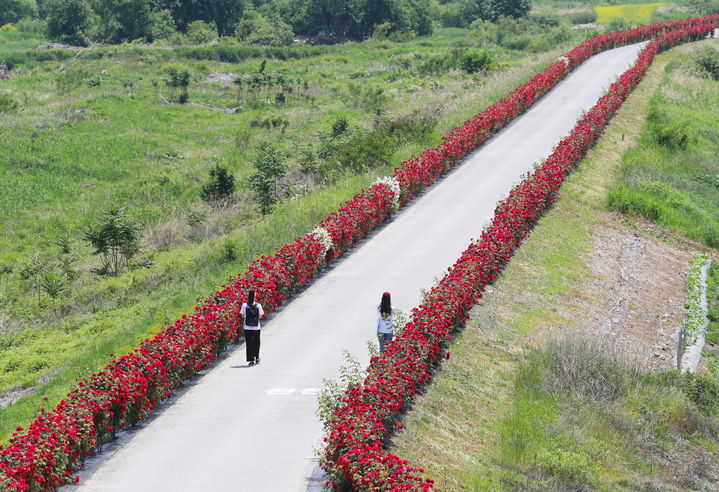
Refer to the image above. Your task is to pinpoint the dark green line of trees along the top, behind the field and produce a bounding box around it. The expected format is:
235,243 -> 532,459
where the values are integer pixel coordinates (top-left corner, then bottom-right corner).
0,0 -> 531,46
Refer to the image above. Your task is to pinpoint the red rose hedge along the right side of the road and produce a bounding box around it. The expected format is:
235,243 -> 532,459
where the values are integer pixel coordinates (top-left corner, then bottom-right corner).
322,16 -> 719,491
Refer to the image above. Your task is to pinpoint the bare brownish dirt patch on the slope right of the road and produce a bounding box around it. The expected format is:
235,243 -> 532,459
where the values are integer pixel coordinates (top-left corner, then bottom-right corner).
531,213 -> 698,370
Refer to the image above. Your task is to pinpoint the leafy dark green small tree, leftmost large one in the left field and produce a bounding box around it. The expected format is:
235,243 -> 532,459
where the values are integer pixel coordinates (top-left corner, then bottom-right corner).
84,207 -> 142,275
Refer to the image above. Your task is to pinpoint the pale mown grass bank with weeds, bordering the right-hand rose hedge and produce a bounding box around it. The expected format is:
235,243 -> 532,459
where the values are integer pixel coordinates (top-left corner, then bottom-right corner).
391,41 -> 719,491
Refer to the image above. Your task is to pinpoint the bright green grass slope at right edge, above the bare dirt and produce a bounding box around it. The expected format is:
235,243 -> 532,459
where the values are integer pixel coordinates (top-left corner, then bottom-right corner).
609,47 -> 719,248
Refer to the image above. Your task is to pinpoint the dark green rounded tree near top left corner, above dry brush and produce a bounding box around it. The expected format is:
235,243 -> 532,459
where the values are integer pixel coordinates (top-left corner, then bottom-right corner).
45,0 -> 93,46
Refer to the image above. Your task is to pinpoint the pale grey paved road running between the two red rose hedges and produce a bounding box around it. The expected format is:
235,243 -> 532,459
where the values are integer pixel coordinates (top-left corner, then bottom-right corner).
66,45 -> 640,492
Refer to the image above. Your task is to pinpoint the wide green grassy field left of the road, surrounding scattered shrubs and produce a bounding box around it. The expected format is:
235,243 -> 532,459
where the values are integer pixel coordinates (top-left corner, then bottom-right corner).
0,24 -> 575,436
